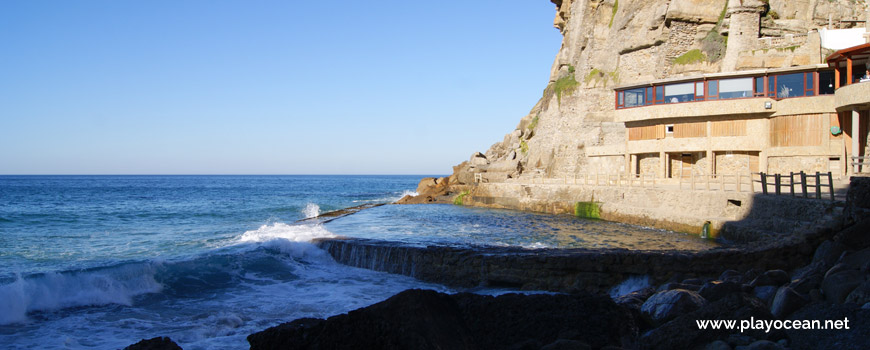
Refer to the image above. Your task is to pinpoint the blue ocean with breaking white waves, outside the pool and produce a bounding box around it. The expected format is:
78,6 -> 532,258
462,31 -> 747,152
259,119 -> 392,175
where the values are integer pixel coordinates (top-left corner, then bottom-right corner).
0,176 -> 451,350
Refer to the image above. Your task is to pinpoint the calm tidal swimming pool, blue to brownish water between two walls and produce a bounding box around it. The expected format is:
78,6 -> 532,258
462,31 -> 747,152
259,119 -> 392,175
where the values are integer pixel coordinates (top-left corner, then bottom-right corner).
324,204 -> 719,251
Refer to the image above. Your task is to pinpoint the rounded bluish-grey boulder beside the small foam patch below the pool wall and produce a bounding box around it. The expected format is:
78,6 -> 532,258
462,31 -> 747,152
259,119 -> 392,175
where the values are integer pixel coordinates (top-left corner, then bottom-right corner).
640,289 -> 707,325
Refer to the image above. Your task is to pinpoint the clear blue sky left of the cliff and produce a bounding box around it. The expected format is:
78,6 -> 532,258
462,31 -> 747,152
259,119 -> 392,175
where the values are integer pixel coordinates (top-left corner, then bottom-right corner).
0,0 -> 561,174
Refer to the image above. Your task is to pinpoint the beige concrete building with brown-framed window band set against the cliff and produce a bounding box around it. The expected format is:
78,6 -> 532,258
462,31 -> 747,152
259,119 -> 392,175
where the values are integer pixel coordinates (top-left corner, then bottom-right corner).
612,6 -> 870,182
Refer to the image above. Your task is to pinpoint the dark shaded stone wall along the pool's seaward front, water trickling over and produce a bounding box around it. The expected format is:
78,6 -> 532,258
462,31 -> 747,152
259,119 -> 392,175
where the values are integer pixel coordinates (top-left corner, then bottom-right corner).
316,231 -> 819,293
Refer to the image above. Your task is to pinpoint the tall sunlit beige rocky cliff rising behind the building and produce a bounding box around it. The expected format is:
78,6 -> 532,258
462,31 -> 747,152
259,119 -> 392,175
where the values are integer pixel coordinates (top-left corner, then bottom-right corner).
404,0 -> 866,202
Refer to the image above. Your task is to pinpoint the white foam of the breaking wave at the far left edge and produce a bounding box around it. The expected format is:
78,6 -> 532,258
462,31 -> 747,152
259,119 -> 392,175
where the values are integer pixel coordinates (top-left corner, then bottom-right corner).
0,264 -> 163,324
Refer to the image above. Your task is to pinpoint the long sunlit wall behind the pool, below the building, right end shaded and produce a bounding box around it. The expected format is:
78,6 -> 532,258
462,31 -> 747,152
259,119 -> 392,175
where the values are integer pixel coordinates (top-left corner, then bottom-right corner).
454,183 -> 843,242
